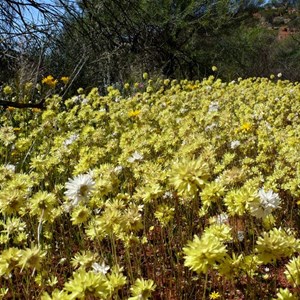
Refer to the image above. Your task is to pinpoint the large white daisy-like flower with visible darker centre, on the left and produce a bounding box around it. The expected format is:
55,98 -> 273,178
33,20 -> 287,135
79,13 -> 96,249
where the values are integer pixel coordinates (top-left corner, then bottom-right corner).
65,174 -> 95,206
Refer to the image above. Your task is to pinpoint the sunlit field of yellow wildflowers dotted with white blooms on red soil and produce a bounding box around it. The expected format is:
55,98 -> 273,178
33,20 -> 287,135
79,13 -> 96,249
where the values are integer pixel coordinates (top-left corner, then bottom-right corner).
0,76 -> 300,300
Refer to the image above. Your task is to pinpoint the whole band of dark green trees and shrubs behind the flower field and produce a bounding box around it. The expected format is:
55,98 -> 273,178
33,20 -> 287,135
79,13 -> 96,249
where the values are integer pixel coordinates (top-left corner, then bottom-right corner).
4,0 -> 299,95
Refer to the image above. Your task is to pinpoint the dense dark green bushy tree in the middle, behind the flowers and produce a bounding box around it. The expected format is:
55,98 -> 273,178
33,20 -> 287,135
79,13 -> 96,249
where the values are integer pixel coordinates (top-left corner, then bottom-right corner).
50,0 -> 257,86
